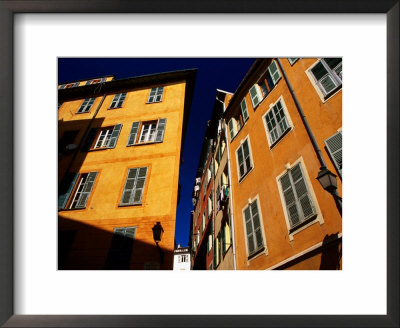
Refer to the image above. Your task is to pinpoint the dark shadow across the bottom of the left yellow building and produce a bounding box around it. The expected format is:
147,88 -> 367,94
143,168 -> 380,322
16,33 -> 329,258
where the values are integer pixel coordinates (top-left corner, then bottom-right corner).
58,215 -> 173,270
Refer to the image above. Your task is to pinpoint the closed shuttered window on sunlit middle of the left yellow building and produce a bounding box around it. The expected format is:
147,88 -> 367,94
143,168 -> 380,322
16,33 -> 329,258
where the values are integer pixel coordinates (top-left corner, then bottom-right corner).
120,167 -> 147,206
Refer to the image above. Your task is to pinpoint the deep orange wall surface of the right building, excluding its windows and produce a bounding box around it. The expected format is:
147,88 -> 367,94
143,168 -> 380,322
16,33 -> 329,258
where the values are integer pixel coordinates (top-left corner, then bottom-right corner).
226,58 -> 342,270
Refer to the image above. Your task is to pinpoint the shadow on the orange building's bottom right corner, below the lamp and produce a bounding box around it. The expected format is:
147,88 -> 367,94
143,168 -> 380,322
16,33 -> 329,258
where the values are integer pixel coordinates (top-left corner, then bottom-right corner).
275,233 -> 342,270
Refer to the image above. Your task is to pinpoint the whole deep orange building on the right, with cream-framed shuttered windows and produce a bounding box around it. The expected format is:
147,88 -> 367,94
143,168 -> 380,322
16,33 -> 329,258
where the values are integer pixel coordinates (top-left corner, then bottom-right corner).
225,58 -> 342,270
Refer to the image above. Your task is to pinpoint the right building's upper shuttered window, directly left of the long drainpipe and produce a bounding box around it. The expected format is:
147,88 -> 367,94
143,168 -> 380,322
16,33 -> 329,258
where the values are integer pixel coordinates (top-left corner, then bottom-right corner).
264,100 -> 290,146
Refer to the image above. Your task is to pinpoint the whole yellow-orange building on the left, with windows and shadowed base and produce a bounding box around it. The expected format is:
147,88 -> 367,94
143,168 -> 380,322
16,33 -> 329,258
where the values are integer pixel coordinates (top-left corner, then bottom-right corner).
58,70 -> 196,270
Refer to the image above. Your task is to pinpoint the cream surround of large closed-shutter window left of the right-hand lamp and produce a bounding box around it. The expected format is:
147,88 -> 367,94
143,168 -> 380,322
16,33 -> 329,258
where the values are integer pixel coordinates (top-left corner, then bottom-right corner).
276,157 -> 324,241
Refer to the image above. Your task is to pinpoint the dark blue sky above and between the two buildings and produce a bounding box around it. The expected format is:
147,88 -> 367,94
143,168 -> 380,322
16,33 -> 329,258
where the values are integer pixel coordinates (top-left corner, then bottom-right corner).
58,58 -> 255,246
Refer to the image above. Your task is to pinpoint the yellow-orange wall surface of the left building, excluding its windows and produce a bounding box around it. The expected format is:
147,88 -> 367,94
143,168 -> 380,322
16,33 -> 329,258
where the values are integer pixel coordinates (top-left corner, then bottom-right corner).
59,82 -> 185,269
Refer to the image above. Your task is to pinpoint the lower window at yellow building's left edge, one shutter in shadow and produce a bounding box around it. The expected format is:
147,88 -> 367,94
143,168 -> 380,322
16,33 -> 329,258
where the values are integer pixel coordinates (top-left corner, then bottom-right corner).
58,172 -> 97,209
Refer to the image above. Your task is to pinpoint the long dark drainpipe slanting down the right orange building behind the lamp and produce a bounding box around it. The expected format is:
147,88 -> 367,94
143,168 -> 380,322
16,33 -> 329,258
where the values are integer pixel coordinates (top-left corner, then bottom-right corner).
276,58 -> 342,215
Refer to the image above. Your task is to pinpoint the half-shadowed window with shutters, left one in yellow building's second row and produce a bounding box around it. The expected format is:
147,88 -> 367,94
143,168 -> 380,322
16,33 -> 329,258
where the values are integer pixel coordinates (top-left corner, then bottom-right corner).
82,124 -> 122,151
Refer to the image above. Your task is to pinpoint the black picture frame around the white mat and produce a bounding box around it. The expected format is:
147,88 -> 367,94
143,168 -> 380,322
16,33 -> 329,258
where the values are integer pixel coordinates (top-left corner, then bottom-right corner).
0,0 -> 399,327
